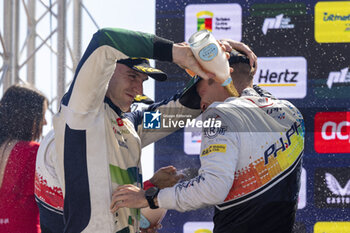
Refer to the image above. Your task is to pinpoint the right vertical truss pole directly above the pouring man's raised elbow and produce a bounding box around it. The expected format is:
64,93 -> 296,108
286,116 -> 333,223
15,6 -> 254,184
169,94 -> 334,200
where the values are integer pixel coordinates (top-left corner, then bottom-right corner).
73,0 -> 82,71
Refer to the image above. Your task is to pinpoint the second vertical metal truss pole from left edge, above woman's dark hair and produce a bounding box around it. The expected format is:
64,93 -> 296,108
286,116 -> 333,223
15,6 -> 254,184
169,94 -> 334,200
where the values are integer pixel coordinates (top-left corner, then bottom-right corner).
11,0 -> 19,85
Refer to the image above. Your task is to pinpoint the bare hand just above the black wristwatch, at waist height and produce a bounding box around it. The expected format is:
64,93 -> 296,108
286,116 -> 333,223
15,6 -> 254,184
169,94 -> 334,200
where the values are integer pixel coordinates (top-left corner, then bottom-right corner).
150,166 -> 184,189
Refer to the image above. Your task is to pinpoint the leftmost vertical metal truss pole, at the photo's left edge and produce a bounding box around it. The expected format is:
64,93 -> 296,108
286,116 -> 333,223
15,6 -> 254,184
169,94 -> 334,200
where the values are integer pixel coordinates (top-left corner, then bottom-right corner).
3,1 -> 13,92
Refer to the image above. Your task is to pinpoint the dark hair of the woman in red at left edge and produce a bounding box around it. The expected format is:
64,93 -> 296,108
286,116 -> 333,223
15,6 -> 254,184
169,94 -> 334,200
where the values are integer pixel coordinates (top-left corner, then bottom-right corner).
0,84 -> 48,145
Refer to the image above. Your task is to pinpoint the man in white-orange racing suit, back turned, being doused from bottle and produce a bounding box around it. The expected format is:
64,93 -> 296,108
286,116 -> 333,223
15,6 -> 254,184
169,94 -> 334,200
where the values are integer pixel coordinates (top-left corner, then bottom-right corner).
111,52 -> 305,233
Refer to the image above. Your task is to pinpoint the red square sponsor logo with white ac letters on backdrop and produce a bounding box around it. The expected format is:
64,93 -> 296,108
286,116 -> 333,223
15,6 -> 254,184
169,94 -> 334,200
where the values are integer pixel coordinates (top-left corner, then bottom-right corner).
314,112 -> 350,153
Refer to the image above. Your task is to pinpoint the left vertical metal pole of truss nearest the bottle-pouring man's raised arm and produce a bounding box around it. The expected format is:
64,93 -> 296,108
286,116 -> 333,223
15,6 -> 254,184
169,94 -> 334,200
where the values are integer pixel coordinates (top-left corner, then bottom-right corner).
57,0 -> 66,108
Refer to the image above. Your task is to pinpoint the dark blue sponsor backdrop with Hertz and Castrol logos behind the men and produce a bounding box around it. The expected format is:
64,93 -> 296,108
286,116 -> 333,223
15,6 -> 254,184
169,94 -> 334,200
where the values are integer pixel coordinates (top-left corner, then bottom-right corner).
154,0 -> 350,233
